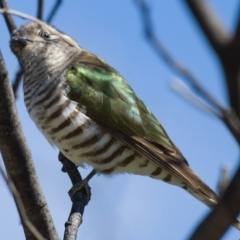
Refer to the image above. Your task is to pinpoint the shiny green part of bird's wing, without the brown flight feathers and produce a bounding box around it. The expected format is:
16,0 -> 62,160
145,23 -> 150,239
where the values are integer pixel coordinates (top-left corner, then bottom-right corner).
67,51 -> 176,156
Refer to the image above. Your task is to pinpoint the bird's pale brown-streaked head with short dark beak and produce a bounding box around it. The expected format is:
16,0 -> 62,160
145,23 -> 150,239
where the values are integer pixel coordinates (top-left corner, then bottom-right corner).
10,22 -> 81,71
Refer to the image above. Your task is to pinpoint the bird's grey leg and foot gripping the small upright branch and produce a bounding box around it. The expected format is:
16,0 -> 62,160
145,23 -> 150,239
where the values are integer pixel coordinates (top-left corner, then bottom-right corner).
68,169 -> 96,205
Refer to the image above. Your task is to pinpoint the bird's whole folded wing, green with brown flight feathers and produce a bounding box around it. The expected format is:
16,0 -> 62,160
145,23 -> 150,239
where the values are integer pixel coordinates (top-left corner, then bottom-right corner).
66,51 -> 218,202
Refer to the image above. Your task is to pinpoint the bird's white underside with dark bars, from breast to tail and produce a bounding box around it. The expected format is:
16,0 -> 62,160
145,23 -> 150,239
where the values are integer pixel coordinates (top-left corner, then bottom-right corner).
25,79 -> 215,210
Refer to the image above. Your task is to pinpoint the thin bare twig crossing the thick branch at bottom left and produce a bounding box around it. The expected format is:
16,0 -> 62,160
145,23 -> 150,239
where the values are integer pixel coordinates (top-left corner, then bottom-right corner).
0,164 -> 45,240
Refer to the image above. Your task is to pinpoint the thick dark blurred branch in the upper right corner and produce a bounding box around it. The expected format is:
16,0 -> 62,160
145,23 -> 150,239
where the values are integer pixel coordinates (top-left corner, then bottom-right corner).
185,0 -> 240,117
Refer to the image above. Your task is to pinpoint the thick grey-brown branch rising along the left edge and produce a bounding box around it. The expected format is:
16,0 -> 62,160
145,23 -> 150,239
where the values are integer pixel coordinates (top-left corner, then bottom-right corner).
0,49 -> 59,240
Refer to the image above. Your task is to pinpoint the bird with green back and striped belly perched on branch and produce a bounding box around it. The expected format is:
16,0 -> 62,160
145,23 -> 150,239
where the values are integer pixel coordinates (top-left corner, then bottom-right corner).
10,21 -> 240,229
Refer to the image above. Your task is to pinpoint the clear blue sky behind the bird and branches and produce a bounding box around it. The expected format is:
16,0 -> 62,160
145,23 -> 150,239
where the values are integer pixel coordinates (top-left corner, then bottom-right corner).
0,0 -> 240,240
